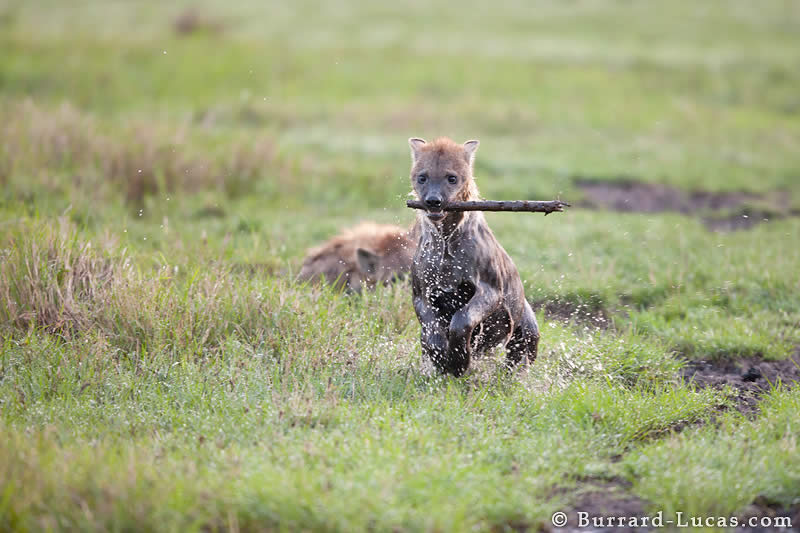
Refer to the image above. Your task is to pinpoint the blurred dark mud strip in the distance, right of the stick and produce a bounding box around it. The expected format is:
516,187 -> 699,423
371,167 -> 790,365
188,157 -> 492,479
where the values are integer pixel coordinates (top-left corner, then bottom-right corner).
575,176 -> 798,231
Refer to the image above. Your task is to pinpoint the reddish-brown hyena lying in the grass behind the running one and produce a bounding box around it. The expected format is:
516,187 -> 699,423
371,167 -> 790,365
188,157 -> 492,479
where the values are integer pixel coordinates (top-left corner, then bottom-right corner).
298,222 -> 417,292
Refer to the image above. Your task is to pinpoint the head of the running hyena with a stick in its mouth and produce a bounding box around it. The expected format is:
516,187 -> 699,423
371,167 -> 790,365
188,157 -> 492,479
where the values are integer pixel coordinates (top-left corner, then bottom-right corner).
408,137 -> 479,223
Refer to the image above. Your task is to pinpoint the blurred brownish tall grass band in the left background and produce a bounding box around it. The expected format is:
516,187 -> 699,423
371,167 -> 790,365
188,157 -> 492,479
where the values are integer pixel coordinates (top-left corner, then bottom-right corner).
0,100 -> 286,204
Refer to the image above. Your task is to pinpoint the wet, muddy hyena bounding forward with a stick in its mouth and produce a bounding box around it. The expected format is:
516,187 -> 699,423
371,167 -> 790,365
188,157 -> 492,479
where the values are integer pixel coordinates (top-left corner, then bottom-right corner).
409,138 -> 539,376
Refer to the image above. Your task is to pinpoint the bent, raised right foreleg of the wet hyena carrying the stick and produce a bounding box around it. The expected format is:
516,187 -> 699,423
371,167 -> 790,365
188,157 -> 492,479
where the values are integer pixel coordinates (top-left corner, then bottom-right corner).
447,284 -> 501,376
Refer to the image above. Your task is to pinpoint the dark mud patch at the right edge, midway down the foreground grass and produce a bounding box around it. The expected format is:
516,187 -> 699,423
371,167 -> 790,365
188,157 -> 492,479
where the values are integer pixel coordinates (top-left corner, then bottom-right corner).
682,352 -> 800,415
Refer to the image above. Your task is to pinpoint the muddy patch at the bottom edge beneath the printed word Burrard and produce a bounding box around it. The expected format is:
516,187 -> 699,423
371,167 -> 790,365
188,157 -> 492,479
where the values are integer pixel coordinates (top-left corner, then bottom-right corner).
545,478 -> 650,533
